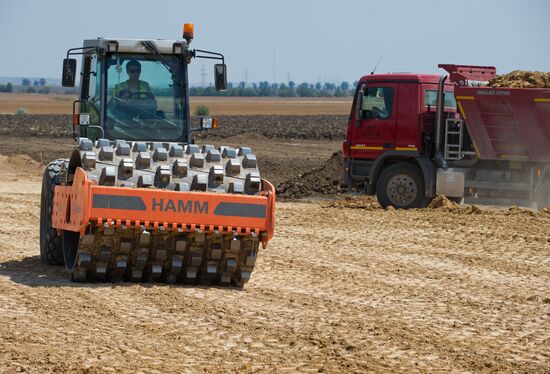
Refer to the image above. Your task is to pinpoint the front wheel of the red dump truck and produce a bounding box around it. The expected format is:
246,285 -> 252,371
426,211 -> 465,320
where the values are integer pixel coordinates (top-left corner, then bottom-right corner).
376,162 -> 429,209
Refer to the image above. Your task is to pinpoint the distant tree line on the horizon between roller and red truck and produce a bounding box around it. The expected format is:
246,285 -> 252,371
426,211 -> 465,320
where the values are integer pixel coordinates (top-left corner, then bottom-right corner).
189,81 -> 356,97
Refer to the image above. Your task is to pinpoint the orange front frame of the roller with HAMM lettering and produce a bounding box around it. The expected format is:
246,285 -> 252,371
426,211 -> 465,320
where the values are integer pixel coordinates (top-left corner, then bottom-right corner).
52,168 -> 275,248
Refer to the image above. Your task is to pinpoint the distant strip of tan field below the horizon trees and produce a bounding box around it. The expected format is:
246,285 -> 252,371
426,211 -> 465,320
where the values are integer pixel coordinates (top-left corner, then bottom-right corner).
0,93 -> 352,115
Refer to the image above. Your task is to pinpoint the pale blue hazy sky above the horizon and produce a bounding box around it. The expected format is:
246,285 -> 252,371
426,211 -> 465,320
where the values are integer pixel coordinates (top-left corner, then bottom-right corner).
0,0 -> 550,83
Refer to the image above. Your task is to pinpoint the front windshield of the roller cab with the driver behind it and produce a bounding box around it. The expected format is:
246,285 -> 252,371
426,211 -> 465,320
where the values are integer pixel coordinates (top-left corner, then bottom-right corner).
105,54 -> 187,141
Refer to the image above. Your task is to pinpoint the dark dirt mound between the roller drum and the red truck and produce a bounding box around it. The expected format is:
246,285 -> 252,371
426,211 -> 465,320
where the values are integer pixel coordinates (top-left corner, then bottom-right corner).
277,151 -> 344,199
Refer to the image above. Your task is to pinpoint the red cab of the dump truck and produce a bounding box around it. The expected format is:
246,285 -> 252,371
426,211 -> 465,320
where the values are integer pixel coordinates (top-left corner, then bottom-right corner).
343,74 -> 456,207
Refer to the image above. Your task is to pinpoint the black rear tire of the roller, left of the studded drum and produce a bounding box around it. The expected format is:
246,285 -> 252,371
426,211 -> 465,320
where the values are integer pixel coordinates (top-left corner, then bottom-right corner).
40,160 -> 67,265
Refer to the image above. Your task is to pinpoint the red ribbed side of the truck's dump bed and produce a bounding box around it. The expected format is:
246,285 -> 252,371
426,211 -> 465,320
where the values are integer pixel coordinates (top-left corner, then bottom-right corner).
454,85 -> 550,162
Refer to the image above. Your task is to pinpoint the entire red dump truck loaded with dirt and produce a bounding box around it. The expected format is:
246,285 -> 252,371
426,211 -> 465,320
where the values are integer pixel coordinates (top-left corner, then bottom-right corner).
343,64 -> 550,209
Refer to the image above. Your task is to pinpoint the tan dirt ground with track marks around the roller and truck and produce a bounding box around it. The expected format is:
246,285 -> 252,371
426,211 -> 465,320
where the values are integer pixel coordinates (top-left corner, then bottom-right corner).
0,115 -> 550,373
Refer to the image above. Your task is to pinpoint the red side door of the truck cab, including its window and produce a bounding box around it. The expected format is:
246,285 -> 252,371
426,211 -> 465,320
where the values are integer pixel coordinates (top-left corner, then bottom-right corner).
349,82 -> 397,160
